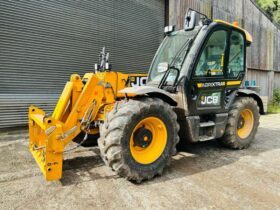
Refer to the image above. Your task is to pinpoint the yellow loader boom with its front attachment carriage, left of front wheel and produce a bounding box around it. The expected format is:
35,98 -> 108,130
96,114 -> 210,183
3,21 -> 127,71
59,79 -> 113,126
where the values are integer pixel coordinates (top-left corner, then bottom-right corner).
29,72 -> 146,180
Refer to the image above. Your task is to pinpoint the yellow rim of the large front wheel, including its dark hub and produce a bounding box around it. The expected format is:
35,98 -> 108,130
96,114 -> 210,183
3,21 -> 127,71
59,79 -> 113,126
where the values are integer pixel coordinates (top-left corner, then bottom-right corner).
130,117 -> 167,164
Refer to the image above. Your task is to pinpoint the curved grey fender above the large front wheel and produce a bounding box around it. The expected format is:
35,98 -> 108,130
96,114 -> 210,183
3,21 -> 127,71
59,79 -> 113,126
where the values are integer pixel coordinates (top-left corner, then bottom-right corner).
119,85 -> 177,106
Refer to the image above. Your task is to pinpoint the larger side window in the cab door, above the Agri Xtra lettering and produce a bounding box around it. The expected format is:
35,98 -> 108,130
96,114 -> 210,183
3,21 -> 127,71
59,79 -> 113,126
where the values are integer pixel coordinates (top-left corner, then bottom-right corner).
194,30 -> 227,77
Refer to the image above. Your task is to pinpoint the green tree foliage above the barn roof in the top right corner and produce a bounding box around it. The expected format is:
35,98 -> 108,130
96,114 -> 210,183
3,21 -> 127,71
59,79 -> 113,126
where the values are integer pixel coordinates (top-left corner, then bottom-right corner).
256,0 -> 280,23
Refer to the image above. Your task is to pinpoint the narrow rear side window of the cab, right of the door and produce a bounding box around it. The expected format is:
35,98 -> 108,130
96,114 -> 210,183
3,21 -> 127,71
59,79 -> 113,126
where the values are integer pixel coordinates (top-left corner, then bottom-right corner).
228,31 -> 245,78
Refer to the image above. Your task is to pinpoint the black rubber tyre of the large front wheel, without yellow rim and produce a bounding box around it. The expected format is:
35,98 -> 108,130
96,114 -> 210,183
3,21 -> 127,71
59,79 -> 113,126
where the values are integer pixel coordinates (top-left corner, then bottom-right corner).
98,97 -> 179,183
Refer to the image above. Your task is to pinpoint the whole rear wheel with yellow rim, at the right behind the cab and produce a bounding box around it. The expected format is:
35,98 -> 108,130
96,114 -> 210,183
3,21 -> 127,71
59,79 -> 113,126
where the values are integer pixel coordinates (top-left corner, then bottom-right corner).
218,97 -> 260,149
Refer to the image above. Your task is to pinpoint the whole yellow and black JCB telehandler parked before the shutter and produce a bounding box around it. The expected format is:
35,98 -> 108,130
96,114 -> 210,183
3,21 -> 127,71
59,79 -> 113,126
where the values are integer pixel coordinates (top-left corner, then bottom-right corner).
29,9 -> 263,182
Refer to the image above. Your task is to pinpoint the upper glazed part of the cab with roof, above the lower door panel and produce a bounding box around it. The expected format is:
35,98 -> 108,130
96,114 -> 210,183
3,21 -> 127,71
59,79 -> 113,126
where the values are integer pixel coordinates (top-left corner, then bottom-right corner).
148,9 -> 252,89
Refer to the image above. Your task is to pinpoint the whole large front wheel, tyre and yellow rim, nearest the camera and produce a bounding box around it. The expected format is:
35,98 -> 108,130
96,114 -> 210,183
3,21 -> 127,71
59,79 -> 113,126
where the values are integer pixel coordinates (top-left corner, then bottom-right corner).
98,98 -> 179,183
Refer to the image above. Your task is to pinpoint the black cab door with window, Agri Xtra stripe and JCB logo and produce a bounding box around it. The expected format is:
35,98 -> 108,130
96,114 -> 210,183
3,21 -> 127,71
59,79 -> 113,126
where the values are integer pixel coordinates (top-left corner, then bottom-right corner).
186,27 -> 229,115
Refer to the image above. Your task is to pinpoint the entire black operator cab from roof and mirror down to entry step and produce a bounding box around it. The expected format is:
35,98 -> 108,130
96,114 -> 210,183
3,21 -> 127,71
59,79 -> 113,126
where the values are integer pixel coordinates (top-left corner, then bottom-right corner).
148,9 -> 252,141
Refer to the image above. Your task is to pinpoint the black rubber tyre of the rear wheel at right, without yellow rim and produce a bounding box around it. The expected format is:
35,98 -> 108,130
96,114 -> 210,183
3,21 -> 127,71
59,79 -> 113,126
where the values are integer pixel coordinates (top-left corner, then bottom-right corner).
218,97 -> 260,149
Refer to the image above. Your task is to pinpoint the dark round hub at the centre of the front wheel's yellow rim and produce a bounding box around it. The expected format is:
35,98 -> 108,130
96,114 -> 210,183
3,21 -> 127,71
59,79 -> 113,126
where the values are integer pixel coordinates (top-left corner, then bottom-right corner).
133,126 -> 153,148
